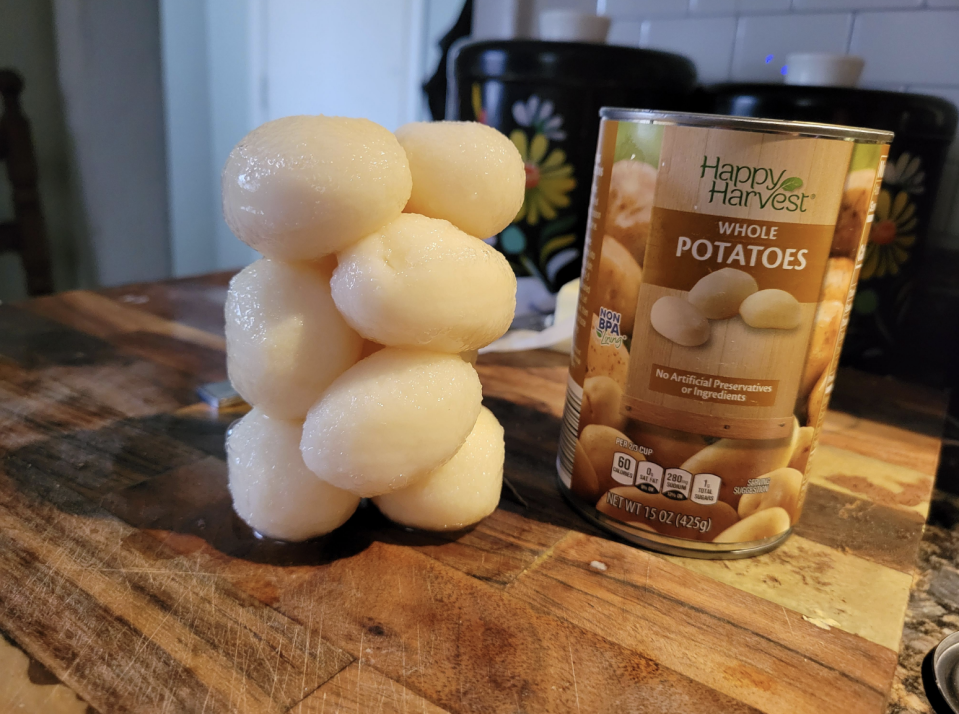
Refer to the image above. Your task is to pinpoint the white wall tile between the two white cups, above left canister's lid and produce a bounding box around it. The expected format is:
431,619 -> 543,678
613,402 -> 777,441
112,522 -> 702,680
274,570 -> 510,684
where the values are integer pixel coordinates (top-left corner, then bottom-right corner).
639,17 -> 736,82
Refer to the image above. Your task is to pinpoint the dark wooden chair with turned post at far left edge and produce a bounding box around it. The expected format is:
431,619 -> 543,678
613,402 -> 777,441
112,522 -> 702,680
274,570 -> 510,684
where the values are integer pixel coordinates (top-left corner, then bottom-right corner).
0,69 -> 53,296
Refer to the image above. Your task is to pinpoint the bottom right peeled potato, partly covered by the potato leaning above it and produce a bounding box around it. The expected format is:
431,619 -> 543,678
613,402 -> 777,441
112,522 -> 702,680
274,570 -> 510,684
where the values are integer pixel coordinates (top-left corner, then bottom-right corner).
373,407 -> 506,531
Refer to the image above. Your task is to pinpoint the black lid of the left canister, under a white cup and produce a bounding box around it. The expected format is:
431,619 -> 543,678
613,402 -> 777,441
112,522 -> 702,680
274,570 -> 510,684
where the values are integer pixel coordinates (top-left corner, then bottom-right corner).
454,40 -> 696,93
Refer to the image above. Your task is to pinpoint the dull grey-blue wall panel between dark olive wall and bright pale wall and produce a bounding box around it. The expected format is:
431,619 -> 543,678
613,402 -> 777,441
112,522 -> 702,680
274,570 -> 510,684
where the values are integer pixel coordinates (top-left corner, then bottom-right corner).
54,0 -> 170,285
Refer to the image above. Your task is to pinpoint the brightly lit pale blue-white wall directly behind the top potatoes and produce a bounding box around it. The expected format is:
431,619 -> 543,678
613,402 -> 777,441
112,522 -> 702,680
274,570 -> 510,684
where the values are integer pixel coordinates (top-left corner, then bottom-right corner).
160,0 -> 454,275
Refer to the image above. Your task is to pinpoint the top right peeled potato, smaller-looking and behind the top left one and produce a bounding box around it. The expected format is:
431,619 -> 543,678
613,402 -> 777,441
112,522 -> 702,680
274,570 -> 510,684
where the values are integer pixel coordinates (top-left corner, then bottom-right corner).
396,121 -> 526,238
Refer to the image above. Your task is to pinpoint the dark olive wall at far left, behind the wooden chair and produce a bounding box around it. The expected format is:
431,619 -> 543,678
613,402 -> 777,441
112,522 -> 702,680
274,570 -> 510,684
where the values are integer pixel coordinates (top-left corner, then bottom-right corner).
0,0 -> 94,301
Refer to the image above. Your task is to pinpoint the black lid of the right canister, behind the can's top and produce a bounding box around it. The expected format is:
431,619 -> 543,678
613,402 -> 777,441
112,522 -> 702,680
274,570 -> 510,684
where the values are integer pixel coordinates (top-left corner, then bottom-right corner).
703,84 -> 959,141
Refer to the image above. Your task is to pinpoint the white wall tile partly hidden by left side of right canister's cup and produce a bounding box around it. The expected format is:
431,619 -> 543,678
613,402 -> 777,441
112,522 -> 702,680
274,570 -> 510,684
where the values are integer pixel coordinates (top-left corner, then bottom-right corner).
732,13 -> 853,82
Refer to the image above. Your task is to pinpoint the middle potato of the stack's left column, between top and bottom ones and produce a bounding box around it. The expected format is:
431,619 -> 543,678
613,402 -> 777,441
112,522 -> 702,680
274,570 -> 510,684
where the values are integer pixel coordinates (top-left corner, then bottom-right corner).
225,256 -> 363,419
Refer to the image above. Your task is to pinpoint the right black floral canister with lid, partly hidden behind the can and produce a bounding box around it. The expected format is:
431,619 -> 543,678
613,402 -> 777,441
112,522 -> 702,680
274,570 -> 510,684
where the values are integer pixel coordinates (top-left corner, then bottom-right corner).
699,84 -> 957,386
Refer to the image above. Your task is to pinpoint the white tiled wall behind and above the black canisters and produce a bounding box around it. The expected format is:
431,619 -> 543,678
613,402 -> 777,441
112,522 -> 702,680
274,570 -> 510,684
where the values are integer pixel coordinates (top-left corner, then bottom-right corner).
537,0 -> 959,250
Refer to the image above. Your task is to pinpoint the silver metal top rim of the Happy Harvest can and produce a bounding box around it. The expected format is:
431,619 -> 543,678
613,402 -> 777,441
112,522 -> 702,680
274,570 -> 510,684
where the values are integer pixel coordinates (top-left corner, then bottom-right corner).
599,107 -> 894,144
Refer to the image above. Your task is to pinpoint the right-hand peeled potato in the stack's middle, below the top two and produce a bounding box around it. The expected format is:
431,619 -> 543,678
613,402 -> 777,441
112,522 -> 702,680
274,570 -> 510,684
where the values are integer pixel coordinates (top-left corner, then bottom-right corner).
331,214 -> 516,352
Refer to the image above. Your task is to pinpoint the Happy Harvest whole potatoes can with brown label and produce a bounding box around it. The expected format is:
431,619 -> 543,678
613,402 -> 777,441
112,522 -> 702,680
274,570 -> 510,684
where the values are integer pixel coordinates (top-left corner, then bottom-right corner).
557,108 -> 892,558
